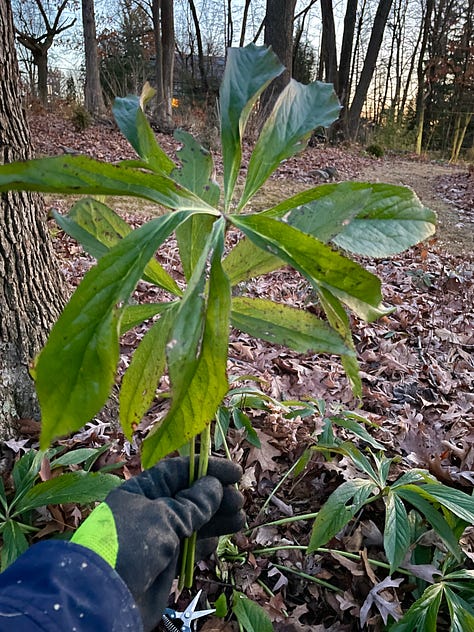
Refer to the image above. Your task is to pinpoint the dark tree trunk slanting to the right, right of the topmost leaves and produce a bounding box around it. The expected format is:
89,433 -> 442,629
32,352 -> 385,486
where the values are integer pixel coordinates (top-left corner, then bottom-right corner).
348,0 -> 393,138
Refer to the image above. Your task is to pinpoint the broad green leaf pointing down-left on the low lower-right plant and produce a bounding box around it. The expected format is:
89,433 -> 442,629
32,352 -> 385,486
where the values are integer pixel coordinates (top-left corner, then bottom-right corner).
308,478 -> 377,553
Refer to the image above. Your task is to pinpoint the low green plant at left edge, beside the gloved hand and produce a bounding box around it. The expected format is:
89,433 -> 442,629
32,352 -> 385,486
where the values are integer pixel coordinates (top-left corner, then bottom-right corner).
0,448 -> 122,571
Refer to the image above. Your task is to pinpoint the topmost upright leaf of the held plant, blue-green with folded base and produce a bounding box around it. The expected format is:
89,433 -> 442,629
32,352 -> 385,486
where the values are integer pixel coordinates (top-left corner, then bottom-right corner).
219,44 -> 284,209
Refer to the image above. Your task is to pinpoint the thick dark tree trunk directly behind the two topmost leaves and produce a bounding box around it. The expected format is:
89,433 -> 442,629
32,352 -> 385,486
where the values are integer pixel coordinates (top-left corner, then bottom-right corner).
260,0 -> 296,118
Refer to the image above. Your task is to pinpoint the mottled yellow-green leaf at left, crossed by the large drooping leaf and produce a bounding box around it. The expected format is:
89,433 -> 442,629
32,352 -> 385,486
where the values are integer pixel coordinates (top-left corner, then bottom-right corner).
64,198 -> 182,296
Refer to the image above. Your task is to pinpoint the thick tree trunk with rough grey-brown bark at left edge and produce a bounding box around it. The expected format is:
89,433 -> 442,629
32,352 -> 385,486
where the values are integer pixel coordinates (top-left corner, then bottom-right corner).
0,0 -> 64,440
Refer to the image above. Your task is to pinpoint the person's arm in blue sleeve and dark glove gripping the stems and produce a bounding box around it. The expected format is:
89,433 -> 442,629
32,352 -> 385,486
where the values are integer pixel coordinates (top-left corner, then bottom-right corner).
0,458 -> 244,632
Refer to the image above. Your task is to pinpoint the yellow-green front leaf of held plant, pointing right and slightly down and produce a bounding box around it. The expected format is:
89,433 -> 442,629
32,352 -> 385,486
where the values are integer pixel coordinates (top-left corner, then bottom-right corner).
229,215 -> 382,318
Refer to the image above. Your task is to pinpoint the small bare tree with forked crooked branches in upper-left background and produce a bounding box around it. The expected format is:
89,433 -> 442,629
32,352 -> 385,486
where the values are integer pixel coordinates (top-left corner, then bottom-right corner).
15,0 -> 76,105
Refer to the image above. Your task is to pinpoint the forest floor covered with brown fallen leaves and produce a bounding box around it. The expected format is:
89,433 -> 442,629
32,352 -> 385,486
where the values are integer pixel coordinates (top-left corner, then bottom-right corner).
24,115 -> 474,632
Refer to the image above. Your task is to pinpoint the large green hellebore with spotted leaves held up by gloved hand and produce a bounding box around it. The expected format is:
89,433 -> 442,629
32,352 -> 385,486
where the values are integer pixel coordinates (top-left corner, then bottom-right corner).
0,44 -> 435,588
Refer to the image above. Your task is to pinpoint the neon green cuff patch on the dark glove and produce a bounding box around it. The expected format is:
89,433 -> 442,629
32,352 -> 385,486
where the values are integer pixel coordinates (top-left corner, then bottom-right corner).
71,503 -> 118,568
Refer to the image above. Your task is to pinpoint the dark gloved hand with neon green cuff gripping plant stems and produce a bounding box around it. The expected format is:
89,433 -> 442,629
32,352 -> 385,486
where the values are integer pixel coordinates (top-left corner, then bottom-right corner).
72,457 -> 245,631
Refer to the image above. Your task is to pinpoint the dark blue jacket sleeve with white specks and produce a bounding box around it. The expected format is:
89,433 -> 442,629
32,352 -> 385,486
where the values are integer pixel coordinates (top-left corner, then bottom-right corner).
0,540 -> 143,632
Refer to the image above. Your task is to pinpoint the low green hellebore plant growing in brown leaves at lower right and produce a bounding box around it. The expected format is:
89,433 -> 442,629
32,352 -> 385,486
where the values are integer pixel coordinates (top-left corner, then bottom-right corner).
308,441 -> 474,632
